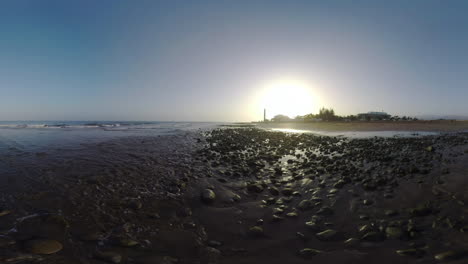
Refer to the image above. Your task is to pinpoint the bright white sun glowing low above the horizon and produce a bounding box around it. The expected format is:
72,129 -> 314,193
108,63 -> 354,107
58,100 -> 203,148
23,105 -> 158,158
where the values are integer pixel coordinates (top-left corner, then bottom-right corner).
261,80 -> 317,118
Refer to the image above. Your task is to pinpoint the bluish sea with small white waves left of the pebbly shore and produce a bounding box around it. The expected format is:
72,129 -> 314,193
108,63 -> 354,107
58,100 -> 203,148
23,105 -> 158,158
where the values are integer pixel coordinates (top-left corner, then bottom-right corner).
0,121 -> 219,152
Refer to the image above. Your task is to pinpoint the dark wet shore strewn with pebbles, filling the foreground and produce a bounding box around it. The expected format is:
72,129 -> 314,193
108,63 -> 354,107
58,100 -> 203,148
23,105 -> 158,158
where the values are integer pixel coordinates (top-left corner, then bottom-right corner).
0,127 -> 468,264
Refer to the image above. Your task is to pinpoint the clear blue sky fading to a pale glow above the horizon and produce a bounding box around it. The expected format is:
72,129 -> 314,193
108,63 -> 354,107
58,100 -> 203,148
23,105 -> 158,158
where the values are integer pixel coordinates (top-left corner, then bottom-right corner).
0,0 -> 468,121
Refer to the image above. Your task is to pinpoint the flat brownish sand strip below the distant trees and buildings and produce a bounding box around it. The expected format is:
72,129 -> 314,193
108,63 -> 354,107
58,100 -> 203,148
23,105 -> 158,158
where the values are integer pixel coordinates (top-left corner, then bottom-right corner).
255,120 -> 468,132
